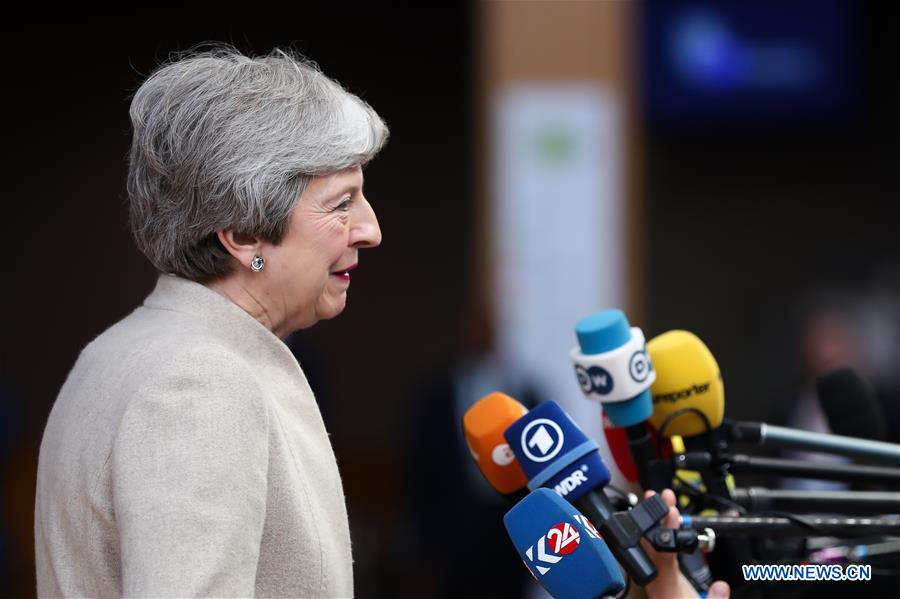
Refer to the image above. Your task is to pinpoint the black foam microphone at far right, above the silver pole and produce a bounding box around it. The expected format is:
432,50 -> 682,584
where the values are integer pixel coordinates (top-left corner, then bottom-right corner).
816,367 -> 887,441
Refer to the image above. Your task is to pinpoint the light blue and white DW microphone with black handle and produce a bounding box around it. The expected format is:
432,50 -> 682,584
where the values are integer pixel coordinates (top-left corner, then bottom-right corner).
569,310 -> 674,492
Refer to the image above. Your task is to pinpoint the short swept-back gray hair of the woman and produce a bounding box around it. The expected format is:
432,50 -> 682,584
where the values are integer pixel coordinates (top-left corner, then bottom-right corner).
127,47 -> 388,281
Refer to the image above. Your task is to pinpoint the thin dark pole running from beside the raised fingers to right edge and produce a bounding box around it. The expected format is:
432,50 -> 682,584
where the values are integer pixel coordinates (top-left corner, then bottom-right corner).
681,516 -> 900,537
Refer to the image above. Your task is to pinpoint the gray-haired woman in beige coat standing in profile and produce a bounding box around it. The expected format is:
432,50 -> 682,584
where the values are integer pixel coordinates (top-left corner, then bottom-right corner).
35,48 -> 388,597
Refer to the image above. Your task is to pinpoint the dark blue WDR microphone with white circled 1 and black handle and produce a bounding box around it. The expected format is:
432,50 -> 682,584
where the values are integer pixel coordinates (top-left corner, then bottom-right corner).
503,401 -> 657,585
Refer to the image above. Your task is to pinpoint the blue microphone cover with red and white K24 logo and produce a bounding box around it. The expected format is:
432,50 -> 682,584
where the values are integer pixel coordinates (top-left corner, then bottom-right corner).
503,489 -> 625,599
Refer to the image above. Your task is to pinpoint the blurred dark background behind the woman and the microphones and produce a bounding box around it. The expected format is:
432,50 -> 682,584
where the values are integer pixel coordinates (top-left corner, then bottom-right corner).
0,0 -> 900,597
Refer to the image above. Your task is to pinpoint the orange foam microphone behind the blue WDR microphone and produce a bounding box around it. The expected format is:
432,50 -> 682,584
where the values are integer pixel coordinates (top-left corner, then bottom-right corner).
463,392 -> 528,495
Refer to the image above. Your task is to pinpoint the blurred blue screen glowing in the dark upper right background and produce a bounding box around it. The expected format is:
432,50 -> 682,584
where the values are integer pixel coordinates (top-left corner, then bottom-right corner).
639,0 -> 860,128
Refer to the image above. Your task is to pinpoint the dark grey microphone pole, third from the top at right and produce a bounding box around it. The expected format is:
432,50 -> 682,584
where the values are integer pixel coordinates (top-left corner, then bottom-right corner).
732,487 -> 900,515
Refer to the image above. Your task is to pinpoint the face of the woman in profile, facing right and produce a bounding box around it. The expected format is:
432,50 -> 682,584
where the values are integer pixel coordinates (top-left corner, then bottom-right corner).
262,167 -> 381,331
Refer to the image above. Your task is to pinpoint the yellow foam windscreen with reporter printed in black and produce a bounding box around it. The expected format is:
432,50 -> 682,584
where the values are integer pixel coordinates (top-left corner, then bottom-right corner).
647,330 -> 725,437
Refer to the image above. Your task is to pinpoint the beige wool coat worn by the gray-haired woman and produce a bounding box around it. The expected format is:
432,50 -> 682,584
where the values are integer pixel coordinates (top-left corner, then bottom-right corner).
35,275 -> 353,597
